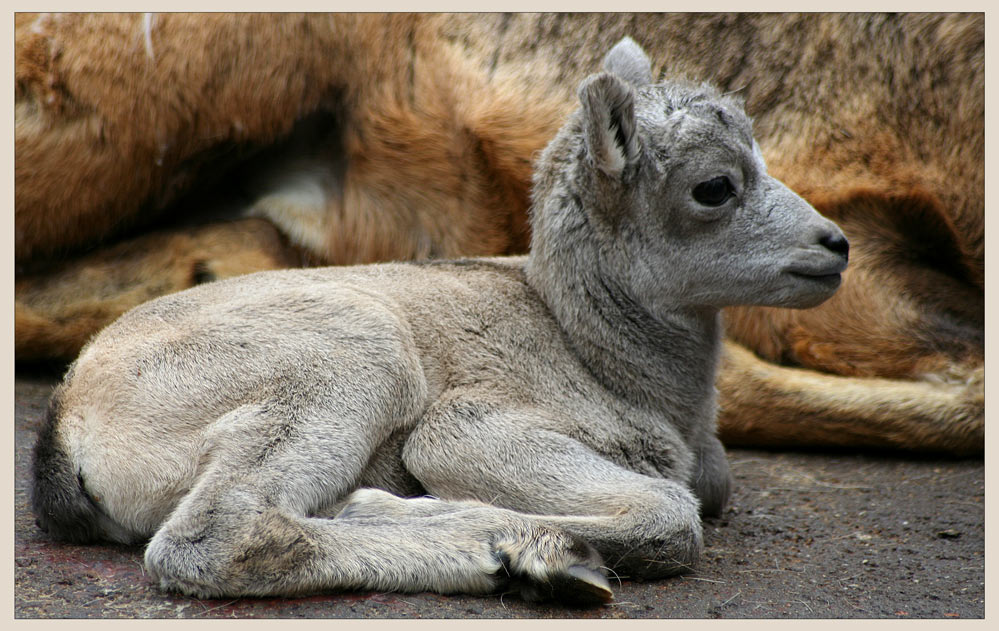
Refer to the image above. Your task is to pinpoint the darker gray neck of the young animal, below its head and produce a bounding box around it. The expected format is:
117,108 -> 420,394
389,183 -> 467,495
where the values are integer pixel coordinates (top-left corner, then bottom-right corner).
527,241 -> 721,433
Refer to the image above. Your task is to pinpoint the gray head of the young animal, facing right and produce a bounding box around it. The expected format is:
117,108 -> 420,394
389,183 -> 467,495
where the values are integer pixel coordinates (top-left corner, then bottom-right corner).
531,39 -> 847,313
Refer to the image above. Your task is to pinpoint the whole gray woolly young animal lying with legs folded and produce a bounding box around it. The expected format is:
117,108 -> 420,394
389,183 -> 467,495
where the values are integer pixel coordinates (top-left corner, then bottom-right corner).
34,43 -> 846,602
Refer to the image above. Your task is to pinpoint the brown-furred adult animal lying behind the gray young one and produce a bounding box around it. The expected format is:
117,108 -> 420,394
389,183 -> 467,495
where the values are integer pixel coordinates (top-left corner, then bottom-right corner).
15,14 -> 985,453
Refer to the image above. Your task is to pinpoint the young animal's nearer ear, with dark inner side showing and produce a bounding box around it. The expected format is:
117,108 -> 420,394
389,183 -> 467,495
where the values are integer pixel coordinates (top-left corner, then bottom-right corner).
579,73 -> 639,178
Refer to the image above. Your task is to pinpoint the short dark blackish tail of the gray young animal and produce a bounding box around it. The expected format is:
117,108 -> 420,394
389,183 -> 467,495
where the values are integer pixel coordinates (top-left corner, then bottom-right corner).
31,389 -> 120,543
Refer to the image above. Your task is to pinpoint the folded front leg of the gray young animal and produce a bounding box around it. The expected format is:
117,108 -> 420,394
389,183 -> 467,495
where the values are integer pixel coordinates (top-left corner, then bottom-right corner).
403,402 -> 702,578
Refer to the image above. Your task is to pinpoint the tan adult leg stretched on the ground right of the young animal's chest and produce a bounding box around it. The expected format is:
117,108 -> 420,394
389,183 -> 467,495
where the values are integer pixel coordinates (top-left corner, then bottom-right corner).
718,342 -> 985,456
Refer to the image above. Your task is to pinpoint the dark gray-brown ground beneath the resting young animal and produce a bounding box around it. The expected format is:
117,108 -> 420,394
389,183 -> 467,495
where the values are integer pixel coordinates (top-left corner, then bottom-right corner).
14,370 -> 985,619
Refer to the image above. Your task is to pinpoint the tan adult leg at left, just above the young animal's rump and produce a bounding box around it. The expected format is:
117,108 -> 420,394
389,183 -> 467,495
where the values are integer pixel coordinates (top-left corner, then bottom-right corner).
14,218 -> 305,361
